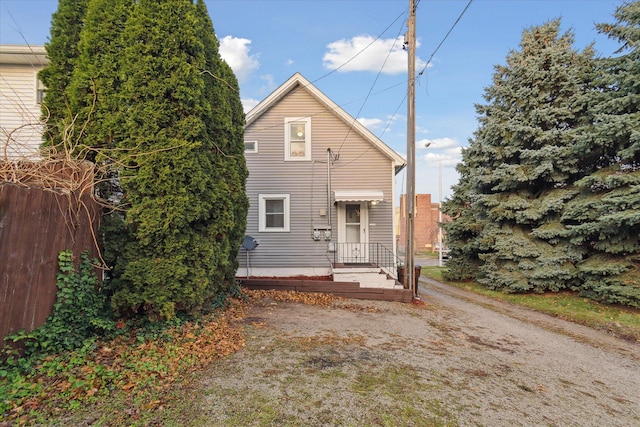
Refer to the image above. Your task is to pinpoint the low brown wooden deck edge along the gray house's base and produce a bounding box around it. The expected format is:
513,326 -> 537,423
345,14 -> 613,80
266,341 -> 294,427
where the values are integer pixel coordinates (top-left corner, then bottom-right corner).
239,278 -> 413,303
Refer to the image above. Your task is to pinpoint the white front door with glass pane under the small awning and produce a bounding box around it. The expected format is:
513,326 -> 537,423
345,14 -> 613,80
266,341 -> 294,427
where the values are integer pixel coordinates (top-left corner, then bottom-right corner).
338,202 -> 369,263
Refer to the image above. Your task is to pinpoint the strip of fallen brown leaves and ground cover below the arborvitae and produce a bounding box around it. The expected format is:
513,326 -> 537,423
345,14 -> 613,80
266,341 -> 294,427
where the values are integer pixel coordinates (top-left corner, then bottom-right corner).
0,290 -> 378,424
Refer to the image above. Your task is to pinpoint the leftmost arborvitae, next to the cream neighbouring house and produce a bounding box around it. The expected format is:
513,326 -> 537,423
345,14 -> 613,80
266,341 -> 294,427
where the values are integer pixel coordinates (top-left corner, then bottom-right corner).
38,0 -> 89,150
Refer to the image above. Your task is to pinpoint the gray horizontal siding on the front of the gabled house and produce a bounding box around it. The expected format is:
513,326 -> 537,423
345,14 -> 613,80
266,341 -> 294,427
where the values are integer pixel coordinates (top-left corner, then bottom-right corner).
239,86 -> 394,276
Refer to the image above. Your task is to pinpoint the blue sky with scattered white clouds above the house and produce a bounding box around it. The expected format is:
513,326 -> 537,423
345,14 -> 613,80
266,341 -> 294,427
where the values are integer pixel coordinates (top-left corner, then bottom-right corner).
0,0 -> 622,201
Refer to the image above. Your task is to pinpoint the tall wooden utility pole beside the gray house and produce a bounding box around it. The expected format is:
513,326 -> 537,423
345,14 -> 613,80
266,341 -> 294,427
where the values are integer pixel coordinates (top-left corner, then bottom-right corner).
404,0 -> 418,298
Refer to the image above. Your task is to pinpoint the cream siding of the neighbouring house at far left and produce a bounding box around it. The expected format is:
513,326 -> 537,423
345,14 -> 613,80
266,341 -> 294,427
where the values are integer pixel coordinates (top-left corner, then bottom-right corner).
0,64 -> 43,159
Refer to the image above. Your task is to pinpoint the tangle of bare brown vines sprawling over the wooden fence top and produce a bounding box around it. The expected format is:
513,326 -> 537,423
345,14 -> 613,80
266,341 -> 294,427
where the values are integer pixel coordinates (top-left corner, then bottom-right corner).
0,82 -> 198,269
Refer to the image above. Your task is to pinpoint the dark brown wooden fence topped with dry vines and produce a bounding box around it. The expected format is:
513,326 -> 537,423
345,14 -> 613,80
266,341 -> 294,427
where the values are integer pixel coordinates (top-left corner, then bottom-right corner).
0,162 -> 101,348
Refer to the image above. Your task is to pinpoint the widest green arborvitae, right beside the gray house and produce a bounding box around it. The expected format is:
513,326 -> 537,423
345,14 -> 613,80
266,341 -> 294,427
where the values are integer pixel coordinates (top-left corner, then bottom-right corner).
113,0 -> 244,318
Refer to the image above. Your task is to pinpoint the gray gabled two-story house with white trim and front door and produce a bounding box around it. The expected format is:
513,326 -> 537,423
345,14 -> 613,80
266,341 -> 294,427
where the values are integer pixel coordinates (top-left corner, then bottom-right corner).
237,73 -> 405,294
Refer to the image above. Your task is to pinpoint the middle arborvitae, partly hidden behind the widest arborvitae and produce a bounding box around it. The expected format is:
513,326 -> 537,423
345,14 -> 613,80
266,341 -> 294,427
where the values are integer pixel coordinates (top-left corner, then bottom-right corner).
66,0 -> 134,294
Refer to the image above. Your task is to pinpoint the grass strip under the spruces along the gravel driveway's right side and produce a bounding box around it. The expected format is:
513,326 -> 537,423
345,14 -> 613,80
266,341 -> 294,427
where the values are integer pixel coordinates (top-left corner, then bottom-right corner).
421,267 -> 640,342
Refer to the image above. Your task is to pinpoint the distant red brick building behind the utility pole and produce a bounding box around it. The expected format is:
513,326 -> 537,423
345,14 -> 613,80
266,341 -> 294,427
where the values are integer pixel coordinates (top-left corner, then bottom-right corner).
396,194 -> 449,252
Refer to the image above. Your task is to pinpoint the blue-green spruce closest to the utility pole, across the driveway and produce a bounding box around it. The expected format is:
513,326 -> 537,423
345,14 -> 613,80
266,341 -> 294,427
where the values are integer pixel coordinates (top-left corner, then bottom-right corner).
446,20 -> 593,292
